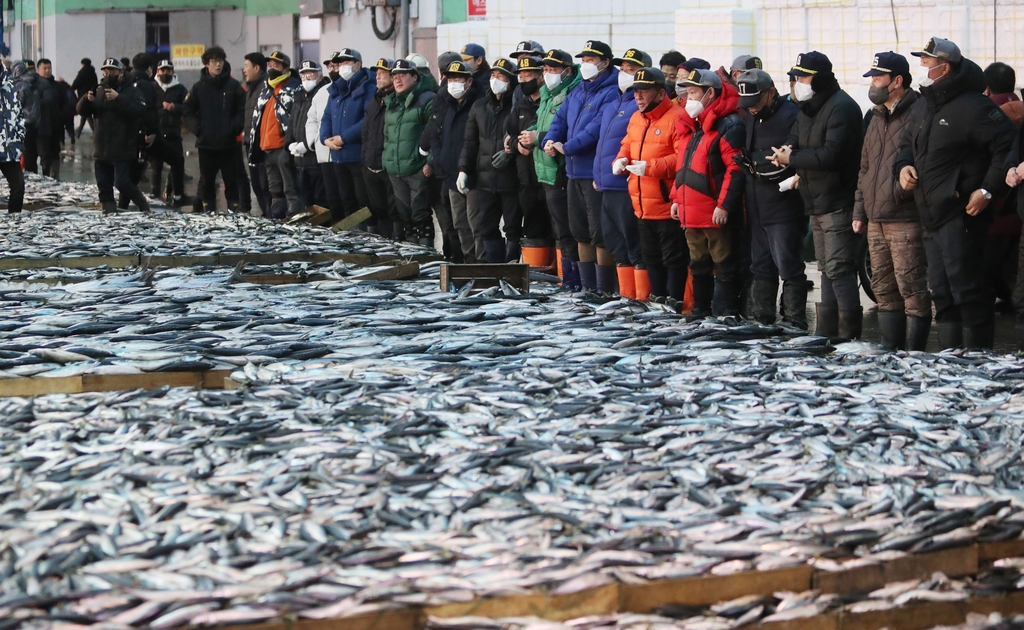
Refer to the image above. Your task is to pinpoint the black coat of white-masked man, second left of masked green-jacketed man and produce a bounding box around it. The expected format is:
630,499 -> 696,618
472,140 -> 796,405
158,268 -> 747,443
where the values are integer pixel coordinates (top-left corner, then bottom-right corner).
459,84 -> 519,193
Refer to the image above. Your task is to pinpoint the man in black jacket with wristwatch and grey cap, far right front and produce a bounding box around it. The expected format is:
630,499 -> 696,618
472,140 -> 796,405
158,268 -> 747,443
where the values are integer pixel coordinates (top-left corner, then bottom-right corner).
895,37 -> 1014,349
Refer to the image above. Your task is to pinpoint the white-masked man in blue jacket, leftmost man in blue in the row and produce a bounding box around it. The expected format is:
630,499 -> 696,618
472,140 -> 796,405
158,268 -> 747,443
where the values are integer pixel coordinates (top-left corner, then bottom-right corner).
321,48 -> 377,220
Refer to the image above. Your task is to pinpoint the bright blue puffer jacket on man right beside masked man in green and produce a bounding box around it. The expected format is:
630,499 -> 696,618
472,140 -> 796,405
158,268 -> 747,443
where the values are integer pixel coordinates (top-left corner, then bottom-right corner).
545,68 -> 618,179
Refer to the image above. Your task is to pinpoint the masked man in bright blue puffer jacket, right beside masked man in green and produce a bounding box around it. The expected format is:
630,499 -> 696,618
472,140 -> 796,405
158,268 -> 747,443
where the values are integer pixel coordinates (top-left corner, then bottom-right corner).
544,40 -> 620,293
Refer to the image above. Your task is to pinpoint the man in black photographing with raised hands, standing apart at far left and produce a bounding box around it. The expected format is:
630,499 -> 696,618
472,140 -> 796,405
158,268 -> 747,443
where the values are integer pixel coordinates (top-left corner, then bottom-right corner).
78,57 -> 150,214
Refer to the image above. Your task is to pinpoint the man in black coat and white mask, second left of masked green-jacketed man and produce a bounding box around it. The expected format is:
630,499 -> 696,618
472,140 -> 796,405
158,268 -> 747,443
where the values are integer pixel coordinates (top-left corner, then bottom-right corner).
460,54 -> 522,263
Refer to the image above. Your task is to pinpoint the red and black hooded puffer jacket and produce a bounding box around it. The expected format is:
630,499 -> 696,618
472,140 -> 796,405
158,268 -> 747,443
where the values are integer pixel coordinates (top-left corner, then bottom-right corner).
672,83 -> 745,228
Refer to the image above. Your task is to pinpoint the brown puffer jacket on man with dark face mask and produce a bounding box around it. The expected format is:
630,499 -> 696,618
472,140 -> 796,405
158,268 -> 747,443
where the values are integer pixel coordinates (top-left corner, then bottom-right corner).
853,90 -> 921,223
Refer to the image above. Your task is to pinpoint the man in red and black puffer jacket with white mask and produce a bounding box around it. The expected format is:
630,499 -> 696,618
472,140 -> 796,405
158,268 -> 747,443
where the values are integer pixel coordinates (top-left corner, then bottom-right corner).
671,70 -> 745,320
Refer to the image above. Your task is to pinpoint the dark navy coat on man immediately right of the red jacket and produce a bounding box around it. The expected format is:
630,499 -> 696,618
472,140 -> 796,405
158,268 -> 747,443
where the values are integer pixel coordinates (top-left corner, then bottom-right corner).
743,94 -> 807,225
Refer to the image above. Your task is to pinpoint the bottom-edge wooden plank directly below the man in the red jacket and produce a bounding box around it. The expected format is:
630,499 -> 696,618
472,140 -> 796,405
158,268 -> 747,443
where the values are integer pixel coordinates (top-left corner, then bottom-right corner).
620,565 -> 814,614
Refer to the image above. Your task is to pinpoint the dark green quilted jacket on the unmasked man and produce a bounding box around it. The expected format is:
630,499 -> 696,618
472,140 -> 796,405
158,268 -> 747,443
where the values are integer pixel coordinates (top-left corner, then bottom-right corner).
382,78 -> 434,177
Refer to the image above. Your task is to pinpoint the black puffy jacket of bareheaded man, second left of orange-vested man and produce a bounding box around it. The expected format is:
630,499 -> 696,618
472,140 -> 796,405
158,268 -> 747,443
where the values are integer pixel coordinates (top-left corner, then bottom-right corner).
182,64 -> 246,151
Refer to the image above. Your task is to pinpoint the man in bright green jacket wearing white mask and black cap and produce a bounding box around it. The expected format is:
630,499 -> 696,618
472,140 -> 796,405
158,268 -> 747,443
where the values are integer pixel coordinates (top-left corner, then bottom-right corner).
519,48 -> 582,291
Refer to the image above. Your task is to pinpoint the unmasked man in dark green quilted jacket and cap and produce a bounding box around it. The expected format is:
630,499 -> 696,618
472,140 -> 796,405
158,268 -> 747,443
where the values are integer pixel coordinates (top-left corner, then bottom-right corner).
382,59 -> 434,239
